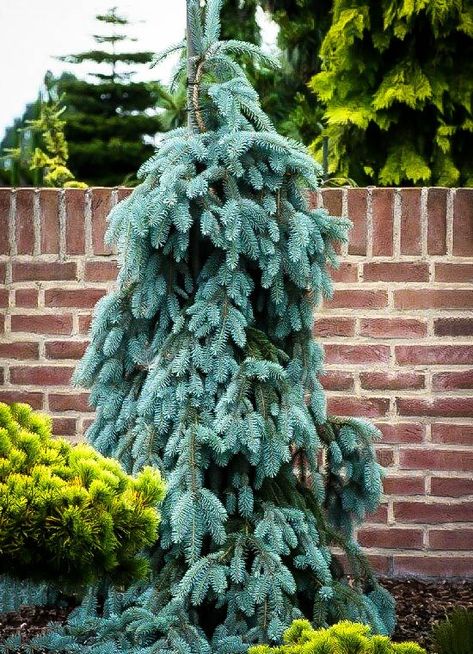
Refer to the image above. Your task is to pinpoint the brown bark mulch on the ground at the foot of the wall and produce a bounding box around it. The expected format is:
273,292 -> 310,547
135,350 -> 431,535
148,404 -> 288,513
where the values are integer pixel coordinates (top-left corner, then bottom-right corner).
0,579 -> 473,651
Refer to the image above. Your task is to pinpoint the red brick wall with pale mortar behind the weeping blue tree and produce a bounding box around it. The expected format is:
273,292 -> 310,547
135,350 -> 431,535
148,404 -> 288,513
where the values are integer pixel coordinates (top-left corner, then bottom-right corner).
0,188 -> 473,576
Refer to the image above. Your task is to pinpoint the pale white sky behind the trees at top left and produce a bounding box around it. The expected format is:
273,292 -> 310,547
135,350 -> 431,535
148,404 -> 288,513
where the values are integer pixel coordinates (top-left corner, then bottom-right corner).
0,0 -> 274,140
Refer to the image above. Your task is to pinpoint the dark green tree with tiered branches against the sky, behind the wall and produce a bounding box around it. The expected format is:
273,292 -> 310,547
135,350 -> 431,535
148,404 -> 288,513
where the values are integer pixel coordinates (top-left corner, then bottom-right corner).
59,7 -> 161,186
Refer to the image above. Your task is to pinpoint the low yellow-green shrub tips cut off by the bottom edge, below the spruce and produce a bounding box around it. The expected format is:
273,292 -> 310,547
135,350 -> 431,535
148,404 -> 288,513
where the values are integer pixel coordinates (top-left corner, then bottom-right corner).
248,620 -> 426,654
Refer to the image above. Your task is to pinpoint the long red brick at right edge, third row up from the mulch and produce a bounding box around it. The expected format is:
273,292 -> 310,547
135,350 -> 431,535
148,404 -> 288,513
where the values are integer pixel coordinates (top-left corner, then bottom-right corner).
394,501 -> 473,524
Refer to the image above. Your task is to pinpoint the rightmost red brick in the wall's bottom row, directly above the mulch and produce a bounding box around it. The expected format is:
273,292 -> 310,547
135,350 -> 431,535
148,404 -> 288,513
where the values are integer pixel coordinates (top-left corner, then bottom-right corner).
393,554 -> 473,578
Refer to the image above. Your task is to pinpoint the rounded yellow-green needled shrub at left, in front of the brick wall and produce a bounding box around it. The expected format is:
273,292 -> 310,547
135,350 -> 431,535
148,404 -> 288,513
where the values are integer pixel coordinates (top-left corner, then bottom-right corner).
0,403 -> 164,583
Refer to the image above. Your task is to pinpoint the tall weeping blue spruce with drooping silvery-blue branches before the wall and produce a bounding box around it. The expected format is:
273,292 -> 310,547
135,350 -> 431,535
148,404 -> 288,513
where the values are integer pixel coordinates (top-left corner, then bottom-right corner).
33,0 -> 394,654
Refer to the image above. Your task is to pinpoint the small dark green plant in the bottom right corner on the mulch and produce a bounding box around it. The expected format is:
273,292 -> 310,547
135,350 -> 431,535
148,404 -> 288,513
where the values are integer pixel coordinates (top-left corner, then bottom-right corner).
432,608 -> 473,654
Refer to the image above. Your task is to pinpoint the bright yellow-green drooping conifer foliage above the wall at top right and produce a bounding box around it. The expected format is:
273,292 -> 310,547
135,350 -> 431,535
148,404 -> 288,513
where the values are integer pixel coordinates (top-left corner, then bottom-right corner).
310,0 -> 473,186
